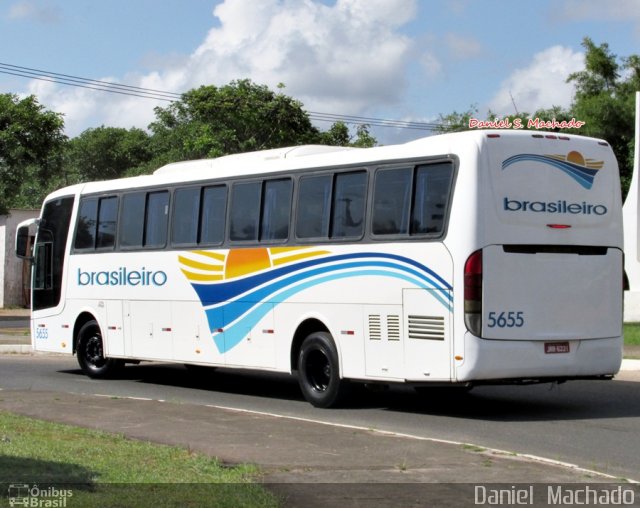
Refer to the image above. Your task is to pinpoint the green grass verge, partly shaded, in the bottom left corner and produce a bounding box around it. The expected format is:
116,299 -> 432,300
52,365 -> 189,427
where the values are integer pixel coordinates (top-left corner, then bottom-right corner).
0,412 -> 279,507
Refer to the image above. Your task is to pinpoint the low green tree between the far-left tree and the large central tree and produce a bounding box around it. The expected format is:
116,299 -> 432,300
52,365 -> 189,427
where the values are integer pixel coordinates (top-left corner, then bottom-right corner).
65,126 -> 153,183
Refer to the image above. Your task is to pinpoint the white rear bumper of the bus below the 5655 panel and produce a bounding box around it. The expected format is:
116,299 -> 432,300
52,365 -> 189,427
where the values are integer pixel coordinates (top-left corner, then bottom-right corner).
455,332 -> 623,382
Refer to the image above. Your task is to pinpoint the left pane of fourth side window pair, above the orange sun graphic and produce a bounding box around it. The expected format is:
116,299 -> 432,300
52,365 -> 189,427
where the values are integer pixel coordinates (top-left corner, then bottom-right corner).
229,182 -> 262,241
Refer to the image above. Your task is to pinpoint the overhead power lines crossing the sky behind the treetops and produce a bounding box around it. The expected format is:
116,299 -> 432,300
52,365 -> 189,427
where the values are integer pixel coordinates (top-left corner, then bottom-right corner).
0,62 -> 442,131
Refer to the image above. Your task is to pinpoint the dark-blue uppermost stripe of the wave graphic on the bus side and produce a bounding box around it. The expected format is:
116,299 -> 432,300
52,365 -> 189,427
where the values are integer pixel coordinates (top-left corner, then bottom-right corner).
191,252 -> 452,306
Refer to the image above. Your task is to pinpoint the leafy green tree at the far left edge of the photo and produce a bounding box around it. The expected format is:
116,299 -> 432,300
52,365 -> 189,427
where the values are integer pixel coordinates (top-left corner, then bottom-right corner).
0,94 -> 67,213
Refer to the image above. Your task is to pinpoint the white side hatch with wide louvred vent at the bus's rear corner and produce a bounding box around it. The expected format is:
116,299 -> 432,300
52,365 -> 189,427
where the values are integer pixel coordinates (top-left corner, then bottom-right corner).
402,289 -> 452,381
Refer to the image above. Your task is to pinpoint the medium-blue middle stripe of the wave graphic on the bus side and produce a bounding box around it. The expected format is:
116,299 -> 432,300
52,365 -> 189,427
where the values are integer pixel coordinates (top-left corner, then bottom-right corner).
207,261 -> 453,330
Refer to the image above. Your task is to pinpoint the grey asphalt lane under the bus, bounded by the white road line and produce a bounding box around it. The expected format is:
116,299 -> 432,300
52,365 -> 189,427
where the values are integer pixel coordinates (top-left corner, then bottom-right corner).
0,355 -> 640,481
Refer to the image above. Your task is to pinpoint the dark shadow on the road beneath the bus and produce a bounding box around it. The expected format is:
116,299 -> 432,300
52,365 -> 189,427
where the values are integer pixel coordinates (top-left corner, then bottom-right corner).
62,363 -> 640,422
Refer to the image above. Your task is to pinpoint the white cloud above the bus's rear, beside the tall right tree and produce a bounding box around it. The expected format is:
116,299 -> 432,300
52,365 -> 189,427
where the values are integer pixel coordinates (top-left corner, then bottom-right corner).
489,46 -> 584,116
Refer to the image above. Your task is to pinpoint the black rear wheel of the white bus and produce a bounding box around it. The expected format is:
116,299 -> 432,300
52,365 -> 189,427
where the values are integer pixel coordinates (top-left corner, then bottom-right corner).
298,332 -> 348,408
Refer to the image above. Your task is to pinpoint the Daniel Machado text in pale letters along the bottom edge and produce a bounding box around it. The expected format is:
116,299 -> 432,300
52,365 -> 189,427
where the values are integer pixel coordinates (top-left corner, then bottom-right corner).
473,483 -> 640,506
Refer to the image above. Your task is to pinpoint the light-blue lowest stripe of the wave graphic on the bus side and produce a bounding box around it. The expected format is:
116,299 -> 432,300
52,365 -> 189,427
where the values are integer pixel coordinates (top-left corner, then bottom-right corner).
212,269 -> 452,353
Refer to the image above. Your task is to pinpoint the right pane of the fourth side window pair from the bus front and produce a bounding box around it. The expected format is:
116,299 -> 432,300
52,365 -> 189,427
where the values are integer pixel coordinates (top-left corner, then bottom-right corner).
260,178 -> 291,242
